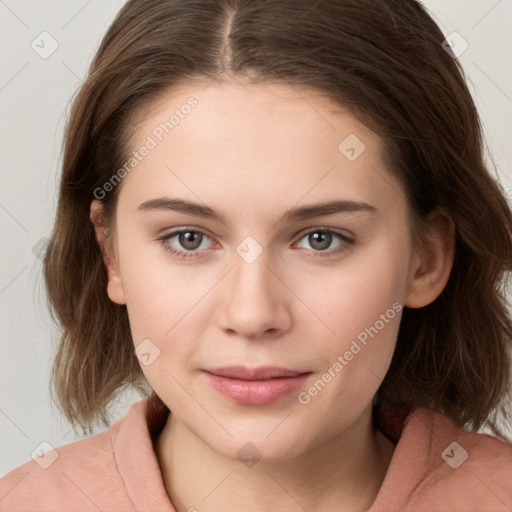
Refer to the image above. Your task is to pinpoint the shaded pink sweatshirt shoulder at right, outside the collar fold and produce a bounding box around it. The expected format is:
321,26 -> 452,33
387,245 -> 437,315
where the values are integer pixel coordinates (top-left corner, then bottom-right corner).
405,408 -> 512,512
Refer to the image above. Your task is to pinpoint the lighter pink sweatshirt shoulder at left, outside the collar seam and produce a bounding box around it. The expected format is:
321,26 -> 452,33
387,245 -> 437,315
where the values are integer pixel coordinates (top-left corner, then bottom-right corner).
0,420 -> 134,512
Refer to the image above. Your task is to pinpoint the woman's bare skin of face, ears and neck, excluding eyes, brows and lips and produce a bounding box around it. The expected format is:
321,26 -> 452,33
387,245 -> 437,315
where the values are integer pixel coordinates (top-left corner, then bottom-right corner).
91,79 -> 454,512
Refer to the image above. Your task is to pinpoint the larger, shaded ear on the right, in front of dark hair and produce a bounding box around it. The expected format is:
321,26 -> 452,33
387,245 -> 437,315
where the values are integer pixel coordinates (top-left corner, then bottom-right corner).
404,208 -> 455,308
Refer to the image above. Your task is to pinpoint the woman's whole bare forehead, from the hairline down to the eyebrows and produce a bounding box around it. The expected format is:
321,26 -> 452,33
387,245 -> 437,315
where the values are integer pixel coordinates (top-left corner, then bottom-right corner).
119,82 -> 399,219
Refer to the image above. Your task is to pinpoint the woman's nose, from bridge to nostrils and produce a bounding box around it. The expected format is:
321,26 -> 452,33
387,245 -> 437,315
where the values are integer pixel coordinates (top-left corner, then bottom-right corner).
219,247 -> 292,339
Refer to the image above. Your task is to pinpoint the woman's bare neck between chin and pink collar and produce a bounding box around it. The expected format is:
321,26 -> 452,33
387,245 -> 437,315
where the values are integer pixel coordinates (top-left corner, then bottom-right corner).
155,406 -> 394,512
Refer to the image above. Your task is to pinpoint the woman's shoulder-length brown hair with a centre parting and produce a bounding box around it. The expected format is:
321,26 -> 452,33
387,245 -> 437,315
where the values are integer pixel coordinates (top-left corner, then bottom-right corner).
44,0 -> 512,436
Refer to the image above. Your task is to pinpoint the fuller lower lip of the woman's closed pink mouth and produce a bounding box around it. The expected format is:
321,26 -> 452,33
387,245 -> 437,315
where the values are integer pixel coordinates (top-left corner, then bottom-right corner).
205,372 -> 310,405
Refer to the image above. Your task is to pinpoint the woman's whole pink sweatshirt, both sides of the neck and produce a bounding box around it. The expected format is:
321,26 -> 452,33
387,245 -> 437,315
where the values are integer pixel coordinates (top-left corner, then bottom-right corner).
0,395 -> 512,512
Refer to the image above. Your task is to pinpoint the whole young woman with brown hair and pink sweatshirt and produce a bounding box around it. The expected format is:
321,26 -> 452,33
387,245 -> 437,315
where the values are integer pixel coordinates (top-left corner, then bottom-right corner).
1,0 -> 512,512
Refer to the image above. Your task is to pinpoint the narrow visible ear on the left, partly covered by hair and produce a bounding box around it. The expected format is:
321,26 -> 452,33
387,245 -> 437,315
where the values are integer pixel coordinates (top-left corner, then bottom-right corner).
90,199 -> 126,304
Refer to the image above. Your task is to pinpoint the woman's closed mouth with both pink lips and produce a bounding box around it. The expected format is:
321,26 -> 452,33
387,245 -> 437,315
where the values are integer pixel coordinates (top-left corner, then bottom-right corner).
204,366 -> 312,405
